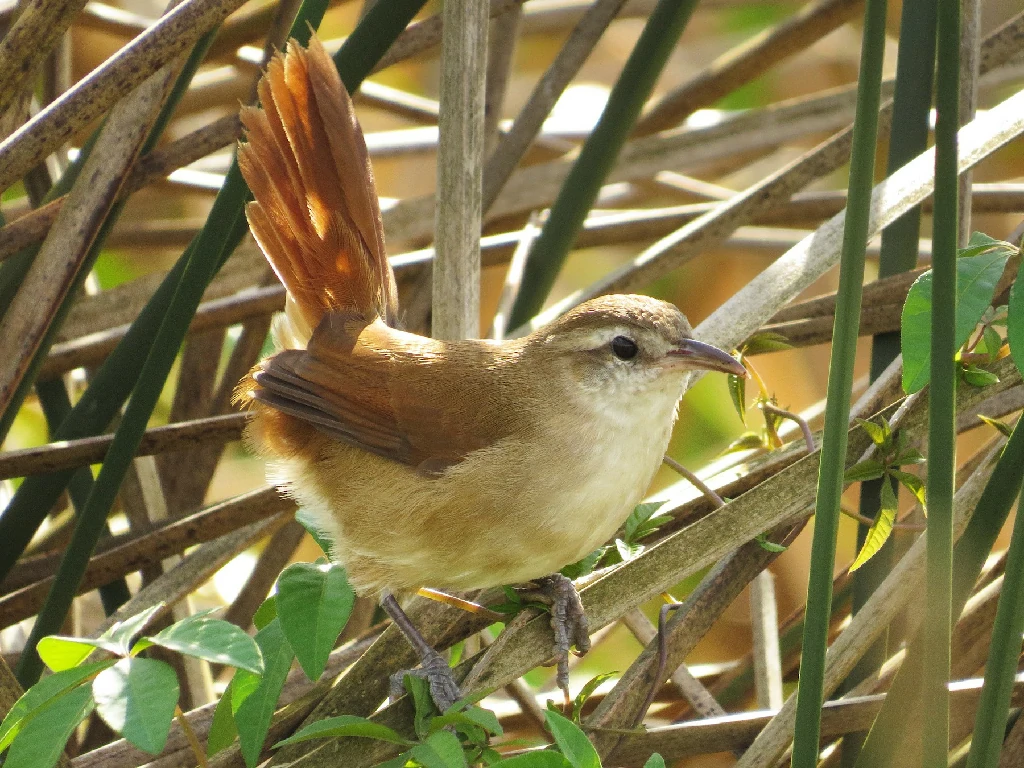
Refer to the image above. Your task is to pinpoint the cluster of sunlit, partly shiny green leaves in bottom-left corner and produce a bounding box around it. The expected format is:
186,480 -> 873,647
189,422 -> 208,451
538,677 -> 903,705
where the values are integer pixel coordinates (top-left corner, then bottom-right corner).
0,604 -> 263,768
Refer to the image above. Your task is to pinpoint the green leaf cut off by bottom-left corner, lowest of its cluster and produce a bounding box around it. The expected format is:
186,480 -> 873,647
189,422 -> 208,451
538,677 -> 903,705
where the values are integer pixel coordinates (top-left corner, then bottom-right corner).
3,685 -> 95,768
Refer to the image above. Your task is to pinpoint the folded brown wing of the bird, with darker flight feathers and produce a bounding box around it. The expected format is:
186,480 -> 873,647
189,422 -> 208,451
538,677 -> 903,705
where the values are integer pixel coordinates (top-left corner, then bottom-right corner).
253,314 -> 505,475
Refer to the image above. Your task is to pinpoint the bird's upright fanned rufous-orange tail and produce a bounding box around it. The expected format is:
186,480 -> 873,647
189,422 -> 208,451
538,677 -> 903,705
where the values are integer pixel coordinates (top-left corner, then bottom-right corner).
239,37 -> 397,348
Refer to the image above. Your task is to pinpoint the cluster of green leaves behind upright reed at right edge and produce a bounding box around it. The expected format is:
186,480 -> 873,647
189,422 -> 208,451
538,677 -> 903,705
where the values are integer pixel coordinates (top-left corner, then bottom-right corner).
900,232 -> 1024,393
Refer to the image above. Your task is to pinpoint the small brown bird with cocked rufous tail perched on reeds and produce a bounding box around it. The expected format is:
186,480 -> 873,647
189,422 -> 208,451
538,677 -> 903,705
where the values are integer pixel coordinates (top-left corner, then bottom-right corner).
237,38 -> 744,710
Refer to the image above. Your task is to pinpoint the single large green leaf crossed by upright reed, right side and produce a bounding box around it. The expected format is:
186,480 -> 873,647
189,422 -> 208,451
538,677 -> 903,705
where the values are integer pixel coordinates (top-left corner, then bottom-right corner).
900,250 -> 1013,394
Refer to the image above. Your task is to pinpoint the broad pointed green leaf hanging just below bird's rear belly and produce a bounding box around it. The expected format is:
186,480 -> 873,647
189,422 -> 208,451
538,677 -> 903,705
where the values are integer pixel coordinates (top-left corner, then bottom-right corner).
278,563 -> 355,680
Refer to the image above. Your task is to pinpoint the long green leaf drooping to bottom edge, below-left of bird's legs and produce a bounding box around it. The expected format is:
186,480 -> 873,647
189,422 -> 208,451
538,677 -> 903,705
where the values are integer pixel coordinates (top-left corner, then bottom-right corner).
231,618 -> 295,768
